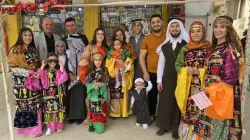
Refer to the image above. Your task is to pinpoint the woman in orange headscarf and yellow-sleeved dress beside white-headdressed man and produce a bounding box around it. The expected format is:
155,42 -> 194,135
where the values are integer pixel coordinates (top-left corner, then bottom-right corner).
175,21 -> 211,140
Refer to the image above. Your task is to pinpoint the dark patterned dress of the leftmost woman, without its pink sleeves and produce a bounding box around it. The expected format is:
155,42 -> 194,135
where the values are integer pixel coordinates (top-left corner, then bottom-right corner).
8,46 -> 42,128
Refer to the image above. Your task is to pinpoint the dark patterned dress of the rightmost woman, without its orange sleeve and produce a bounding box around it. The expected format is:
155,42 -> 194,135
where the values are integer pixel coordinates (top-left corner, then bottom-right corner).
193,43 -> 241,140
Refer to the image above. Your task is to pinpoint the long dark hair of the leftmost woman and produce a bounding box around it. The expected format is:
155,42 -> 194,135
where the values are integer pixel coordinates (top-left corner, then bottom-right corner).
14,28 -> 36,50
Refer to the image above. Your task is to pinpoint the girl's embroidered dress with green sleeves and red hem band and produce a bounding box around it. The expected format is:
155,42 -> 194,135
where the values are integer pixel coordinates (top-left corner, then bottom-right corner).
86,69 -> 109,133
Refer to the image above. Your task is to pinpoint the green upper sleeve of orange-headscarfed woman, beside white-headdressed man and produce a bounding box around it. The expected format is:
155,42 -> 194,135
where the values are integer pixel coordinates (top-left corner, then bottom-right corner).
175,46 -> 188,72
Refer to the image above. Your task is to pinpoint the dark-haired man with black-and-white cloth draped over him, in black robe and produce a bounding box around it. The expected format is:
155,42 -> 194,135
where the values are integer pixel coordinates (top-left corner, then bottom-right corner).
63,17 -> 89,125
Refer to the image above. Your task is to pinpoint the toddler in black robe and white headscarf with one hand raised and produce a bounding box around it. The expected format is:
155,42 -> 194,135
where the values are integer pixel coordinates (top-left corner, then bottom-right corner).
130,78 -> 153,129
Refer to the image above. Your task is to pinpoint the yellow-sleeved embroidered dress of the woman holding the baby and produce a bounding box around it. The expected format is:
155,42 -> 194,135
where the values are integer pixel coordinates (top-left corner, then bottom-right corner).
106,46 -> 136,117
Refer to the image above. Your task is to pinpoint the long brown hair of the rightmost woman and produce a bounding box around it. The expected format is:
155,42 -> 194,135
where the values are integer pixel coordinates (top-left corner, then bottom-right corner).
212,16 -> 241,52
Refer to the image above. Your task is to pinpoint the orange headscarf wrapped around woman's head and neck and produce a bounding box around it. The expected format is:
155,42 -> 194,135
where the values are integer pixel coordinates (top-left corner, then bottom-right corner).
187,21 -> 211,49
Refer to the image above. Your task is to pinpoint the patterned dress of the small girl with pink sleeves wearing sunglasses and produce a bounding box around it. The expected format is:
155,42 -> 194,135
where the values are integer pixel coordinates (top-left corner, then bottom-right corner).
43,70 -> 64,124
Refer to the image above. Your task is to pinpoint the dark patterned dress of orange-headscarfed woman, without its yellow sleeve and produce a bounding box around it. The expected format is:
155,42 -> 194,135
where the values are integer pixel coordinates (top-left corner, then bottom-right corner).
176,46 -> 209,140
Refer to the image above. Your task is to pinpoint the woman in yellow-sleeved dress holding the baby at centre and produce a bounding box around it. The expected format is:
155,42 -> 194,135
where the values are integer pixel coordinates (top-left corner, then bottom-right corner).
108,29 -> 137,119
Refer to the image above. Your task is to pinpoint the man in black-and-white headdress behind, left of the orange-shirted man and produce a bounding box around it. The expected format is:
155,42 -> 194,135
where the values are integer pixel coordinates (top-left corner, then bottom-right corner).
129,19 -> 145,79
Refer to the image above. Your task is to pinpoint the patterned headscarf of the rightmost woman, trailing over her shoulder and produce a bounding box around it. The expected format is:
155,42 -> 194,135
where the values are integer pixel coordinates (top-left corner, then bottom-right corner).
213,16 -> 243,54
